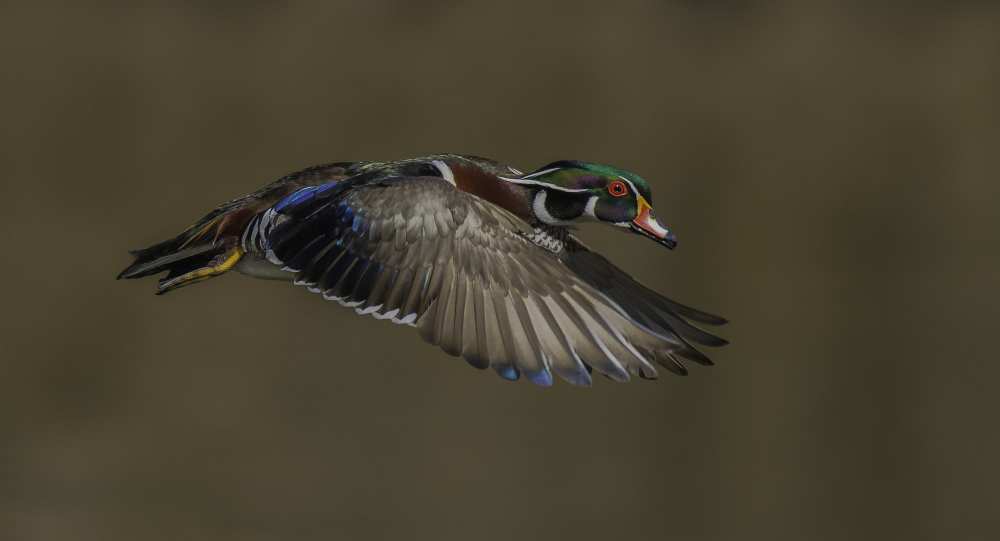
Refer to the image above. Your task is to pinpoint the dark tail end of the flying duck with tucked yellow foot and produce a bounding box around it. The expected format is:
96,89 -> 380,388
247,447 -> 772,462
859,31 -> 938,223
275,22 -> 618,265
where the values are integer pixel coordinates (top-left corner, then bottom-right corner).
118,201 -> 257,295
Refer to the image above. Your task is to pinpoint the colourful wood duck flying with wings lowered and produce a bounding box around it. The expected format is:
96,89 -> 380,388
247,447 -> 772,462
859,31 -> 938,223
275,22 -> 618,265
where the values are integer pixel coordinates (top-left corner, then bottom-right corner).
118,154 -> 727,386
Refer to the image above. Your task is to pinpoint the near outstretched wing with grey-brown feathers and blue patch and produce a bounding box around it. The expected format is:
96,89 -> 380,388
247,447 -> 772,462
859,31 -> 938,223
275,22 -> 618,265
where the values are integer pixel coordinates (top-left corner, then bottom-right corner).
258,177 -> 720,385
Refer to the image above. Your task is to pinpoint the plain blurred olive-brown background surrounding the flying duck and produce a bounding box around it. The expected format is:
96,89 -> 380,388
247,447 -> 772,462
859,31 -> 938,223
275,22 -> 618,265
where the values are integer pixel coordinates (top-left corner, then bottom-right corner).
0,0 -> 1000,540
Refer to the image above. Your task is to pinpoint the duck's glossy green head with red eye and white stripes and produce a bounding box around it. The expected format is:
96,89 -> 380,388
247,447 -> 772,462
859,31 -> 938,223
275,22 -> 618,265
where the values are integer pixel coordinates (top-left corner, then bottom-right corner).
501,160 -> 677,249
